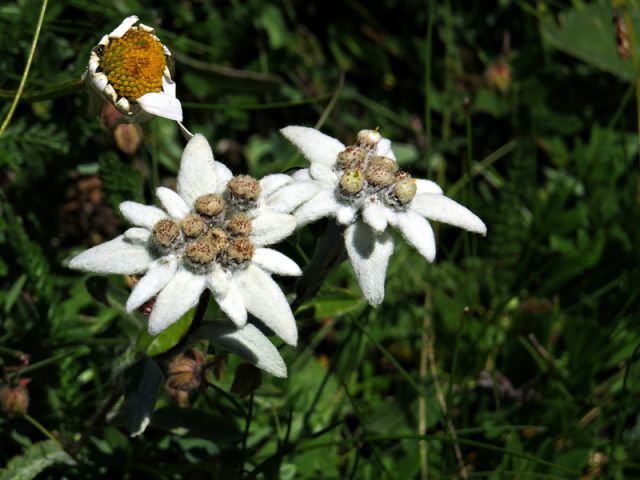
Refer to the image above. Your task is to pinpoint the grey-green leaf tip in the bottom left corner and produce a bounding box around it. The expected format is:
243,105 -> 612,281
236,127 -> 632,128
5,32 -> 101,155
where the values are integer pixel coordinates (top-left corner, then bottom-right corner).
0,440 -> 75,480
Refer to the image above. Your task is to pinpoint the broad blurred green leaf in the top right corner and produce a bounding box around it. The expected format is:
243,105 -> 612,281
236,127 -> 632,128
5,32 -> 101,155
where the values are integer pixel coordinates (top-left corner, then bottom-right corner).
540,5 -> 640,82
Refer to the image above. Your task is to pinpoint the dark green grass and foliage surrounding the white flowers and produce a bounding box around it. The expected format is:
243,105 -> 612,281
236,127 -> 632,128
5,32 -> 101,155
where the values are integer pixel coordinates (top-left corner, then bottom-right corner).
0,0 -> 640,480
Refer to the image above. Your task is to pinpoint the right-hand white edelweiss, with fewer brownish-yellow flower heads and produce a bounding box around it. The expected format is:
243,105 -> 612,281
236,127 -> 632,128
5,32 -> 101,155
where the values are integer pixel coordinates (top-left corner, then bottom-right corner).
281,127 -> 487,306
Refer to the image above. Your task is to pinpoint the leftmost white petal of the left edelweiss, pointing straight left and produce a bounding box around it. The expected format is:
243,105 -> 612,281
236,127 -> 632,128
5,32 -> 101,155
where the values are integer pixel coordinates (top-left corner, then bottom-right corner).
68,235 -> 153,275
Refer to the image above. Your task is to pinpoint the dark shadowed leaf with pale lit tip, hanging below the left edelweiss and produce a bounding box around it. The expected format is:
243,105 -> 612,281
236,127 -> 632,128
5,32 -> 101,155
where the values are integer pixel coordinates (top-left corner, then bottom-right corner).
124,356 -> 163,437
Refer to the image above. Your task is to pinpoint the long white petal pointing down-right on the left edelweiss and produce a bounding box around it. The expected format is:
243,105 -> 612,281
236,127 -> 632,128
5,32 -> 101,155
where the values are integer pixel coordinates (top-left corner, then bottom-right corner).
233,265 -> 298,346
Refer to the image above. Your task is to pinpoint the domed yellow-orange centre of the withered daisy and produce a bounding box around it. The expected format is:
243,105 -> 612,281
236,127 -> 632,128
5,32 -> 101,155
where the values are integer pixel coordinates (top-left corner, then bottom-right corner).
100,29 -> 166,100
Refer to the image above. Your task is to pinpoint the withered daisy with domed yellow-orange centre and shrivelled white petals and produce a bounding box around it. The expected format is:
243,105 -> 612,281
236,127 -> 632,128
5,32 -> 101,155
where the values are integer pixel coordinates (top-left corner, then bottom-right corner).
84,15 -> 182,123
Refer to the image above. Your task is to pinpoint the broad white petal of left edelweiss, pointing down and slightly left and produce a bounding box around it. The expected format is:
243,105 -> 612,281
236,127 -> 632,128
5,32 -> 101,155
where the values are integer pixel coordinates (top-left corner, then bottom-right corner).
149,270 -> 205,335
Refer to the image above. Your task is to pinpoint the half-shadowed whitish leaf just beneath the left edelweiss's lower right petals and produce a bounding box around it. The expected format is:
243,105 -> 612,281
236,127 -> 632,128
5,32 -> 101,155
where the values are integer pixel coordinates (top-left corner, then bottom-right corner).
196,322 -> 287,378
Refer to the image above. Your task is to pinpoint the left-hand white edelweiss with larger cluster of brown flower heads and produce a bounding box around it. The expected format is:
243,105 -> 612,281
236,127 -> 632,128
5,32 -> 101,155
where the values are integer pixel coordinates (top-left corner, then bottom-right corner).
69,135 -> 305,345
